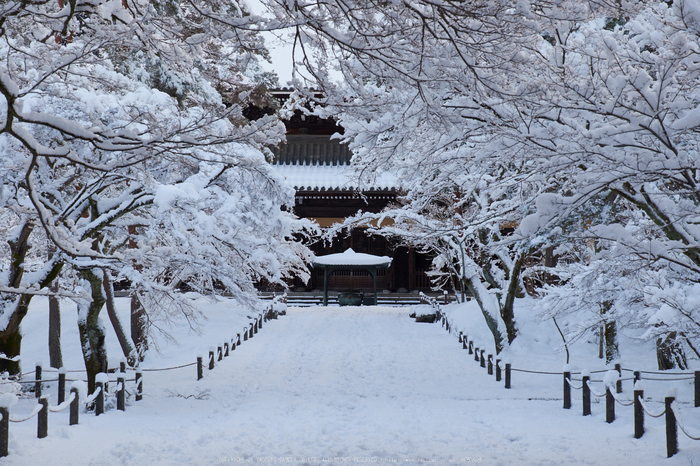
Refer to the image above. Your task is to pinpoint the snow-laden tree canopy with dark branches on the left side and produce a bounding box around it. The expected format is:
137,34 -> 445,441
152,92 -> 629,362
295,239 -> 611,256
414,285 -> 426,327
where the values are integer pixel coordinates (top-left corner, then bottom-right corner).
0,0 -> 307,382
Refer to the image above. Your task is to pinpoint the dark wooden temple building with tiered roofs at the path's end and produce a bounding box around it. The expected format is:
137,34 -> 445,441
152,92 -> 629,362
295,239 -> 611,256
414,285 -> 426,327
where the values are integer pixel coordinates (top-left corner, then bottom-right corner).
273,90 -> 430,293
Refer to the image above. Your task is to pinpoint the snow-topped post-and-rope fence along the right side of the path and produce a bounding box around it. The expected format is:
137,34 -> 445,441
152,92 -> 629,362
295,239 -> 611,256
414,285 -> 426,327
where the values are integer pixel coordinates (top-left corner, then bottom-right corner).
434,310 -> 700,458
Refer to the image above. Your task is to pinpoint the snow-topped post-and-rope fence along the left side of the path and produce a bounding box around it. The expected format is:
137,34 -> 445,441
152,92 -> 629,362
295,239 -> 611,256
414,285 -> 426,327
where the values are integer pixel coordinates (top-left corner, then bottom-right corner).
0,300 -> 286,458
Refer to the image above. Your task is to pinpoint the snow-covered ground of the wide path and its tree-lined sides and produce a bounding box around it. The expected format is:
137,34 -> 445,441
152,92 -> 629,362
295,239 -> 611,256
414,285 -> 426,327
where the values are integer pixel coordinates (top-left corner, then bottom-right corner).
0,300 -> 700,465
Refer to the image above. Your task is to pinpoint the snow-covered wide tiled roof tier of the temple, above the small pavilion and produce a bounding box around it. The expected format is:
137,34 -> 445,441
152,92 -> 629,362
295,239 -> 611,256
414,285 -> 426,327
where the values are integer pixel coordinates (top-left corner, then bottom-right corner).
274,164 -> 396,191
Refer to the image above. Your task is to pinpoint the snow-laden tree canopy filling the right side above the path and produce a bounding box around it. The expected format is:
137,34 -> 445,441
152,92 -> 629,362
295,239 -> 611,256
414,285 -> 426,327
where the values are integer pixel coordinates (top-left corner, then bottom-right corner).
268,0 -> 700,364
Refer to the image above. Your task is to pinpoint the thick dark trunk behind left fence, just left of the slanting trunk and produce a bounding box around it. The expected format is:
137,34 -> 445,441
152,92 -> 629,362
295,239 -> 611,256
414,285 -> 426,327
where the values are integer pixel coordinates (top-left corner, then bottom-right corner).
78,269 -> 108,393
